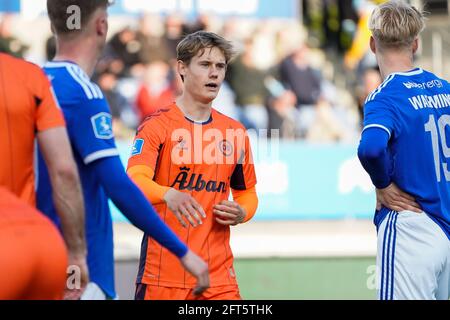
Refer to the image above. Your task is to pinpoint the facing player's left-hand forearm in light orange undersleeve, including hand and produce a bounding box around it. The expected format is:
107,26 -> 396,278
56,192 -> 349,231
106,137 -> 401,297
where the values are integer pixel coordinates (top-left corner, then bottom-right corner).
127,165 -> 206,228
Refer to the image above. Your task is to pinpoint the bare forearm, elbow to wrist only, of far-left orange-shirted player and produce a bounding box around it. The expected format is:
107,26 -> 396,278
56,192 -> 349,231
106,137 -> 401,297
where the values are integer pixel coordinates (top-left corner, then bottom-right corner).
49,163 -> 86,255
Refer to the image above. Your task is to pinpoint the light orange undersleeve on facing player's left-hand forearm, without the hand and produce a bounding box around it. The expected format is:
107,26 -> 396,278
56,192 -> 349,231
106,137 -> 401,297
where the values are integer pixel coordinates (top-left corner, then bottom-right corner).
127,165 -> 170,204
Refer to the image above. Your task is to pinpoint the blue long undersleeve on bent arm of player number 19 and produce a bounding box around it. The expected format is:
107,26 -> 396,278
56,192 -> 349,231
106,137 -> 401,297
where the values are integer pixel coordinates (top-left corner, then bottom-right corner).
358,127 -> 391,189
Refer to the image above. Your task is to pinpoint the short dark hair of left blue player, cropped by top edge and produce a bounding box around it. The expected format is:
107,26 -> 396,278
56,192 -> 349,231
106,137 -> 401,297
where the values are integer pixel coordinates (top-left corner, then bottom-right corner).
47,0 -> 112,34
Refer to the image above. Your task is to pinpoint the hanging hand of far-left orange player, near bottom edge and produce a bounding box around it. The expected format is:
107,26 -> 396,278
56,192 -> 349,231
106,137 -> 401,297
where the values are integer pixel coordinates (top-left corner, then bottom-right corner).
63,253 -> 89,300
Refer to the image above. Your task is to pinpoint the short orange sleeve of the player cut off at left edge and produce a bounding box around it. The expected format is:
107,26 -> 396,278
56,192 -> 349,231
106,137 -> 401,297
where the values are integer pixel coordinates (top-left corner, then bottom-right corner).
33,68 -> 66,131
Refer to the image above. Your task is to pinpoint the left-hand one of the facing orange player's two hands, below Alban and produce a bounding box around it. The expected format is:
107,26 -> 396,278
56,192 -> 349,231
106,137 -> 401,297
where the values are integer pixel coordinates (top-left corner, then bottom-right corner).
164,188 -> 206,228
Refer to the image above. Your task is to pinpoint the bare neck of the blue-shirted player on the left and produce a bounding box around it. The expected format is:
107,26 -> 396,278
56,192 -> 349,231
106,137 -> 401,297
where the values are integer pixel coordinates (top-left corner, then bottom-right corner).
53,37 -> 98,77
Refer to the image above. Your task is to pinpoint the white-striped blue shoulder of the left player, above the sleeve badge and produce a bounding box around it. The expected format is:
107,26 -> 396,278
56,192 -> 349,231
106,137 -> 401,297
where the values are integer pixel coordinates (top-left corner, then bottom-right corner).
44,61 -> 105,101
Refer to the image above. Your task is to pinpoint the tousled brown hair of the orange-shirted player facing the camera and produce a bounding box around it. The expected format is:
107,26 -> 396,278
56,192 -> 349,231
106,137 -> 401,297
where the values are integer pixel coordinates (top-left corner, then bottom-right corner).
177,31 -> 235,65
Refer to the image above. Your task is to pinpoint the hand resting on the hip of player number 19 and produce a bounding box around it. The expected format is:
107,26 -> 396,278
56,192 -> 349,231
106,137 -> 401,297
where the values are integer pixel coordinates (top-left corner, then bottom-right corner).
376,183 -> 422,213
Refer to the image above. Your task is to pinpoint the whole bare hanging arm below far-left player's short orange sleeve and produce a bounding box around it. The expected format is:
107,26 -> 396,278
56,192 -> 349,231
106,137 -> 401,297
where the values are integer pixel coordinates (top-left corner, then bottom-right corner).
37,127 -> 89,289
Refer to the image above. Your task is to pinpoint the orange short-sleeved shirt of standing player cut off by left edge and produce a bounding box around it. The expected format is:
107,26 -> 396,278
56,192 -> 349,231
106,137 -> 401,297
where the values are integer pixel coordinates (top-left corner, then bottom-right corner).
0,53 -> 64,205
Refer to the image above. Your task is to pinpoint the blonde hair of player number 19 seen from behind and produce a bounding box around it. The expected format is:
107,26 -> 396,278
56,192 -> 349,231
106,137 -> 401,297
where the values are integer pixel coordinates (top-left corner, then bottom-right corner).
369,0 -> 425,49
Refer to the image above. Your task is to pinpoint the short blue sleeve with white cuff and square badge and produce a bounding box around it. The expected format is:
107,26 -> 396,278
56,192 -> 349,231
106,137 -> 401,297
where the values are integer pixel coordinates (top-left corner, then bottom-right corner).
65,98 -> 119,164
